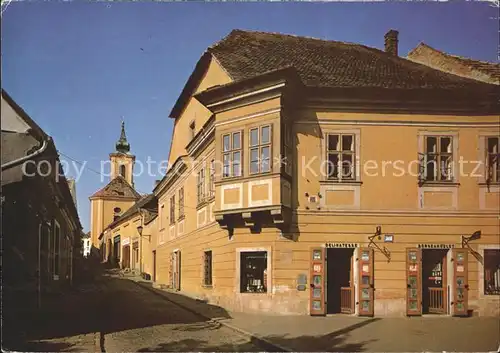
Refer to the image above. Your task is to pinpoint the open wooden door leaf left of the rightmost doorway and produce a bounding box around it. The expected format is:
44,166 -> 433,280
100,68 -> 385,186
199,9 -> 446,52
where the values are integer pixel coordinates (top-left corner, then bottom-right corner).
406,248 -> 422,316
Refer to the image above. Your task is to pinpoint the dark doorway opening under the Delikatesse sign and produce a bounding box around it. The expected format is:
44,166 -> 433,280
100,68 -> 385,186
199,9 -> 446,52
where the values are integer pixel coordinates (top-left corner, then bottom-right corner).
326,248 -> 354,314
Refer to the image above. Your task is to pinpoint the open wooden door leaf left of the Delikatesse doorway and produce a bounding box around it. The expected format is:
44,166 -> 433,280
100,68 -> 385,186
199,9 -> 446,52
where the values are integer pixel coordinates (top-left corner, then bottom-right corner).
309,248 -> 326,316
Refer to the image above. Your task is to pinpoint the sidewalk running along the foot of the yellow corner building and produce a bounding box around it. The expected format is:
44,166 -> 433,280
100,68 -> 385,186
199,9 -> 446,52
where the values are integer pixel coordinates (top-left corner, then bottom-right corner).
131,280 -> 500,352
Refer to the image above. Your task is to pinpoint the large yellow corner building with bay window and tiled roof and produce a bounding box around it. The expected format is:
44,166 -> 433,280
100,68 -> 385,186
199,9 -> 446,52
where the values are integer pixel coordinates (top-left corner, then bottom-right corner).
158,30 -> 500,316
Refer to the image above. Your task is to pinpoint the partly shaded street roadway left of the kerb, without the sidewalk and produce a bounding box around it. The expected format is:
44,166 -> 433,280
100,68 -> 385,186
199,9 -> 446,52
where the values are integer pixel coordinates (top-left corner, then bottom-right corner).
4,277 -> 263,352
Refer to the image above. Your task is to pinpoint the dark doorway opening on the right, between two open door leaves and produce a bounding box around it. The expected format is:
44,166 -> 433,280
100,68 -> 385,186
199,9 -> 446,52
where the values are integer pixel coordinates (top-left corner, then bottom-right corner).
422,249 -> 448,314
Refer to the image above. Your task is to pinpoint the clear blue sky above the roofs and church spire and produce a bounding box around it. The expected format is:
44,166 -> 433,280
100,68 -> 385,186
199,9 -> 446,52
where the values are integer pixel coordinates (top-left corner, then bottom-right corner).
2,1 -> 499,231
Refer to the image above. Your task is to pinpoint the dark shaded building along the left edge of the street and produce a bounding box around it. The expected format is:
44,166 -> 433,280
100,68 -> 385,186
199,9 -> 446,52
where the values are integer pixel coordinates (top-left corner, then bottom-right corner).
1,90 -> 82,310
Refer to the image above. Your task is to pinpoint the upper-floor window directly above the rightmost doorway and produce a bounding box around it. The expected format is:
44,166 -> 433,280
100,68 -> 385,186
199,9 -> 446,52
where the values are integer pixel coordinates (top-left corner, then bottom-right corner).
422,136 -> 453,182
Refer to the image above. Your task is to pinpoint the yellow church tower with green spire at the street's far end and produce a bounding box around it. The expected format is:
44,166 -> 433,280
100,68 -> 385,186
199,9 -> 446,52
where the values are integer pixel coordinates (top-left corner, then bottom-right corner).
89,121 -> 141,249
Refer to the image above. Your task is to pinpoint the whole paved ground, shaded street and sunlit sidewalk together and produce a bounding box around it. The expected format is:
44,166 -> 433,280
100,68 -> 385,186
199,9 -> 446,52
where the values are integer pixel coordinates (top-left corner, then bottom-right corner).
4,276 -> 500,352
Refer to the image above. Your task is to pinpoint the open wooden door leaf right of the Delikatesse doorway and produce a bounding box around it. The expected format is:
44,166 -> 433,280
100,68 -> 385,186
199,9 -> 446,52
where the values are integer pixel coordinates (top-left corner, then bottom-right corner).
358,248 -> 374,316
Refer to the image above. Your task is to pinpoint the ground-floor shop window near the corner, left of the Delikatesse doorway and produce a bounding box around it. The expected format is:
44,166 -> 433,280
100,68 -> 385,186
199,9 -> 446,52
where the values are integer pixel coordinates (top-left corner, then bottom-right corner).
240,251 -> 267,293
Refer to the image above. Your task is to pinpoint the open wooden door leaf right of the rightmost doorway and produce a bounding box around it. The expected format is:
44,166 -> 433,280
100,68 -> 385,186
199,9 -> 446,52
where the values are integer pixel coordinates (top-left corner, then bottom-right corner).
451,249 -> 469,316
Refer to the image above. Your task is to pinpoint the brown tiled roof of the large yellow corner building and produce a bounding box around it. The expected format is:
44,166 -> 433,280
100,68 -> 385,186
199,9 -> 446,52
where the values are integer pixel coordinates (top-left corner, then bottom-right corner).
208,30 -> 496,89
